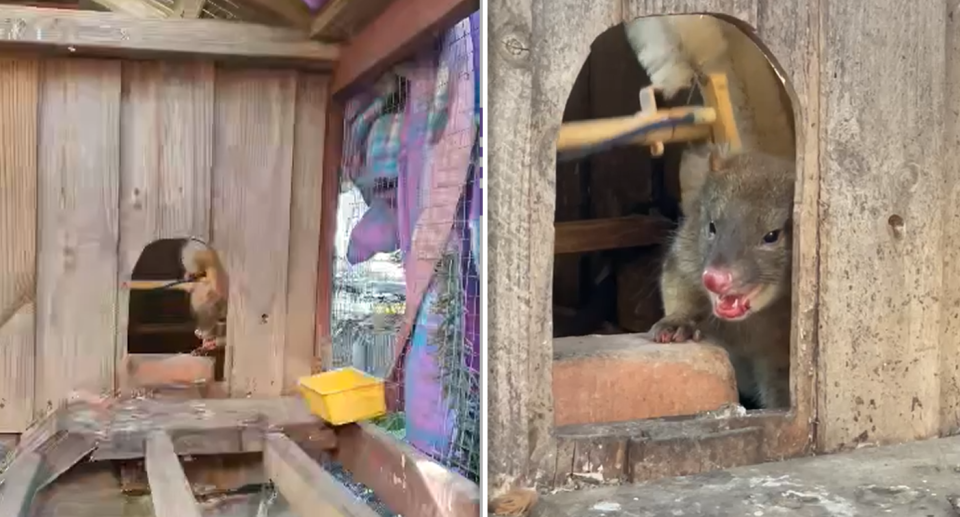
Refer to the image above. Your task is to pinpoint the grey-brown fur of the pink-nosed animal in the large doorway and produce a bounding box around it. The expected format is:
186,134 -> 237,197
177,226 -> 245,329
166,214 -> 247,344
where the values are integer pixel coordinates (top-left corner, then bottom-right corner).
651,153 -> 796,408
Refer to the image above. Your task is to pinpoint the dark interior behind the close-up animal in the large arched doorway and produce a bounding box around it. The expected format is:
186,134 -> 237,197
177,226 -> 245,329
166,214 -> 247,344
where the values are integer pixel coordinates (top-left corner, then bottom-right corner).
553,25 -> 702,337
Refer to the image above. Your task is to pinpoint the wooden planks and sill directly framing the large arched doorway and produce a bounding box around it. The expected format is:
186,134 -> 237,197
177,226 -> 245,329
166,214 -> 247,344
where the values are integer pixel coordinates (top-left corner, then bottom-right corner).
487,0 -> 820,496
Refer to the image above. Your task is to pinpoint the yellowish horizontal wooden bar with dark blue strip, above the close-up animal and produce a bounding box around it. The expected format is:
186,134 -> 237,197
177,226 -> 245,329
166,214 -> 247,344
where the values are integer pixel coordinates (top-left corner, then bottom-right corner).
557,107 -> 717,151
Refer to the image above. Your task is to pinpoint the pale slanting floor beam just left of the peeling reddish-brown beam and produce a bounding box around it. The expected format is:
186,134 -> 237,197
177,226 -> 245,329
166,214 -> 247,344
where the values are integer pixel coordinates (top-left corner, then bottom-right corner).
263,433 -> 377,517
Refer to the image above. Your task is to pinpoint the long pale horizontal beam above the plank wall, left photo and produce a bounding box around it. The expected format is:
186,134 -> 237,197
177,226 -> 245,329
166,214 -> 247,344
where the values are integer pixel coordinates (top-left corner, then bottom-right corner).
0,5 -> 340,70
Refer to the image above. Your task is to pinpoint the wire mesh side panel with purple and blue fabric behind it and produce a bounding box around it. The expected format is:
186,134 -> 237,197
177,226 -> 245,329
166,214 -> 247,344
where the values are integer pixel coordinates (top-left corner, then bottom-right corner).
330,13 -> 481,481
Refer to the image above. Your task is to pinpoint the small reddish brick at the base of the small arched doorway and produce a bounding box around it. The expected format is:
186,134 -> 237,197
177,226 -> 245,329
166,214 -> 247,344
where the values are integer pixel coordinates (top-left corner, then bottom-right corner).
123,354 -> 214,388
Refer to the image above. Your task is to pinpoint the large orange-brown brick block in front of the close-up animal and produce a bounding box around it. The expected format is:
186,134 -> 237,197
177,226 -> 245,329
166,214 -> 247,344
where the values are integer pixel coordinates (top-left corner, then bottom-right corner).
553,334 -> 738,426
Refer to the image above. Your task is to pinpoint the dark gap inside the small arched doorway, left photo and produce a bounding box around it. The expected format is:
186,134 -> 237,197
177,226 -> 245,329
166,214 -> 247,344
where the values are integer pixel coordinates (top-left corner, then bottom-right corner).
127,238 -> 225,382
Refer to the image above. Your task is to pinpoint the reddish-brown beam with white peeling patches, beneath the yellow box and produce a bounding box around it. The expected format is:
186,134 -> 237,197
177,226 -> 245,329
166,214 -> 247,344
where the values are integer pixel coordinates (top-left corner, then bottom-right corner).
334,423 -> 480,517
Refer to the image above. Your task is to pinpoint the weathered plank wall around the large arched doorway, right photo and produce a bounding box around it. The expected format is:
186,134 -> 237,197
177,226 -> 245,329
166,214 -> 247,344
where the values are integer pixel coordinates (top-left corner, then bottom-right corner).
496,0 -> 960,495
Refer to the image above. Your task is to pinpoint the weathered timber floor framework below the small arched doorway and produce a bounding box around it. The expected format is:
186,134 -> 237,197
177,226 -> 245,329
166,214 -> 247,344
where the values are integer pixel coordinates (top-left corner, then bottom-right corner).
0,398 -> 480,517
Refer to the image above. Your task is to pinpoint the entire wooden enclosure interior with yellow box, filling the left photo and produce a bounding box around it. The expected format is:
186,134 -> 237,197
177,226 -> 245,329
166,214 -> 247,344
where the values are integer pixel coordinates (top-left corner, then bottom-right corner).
0,0 -> 482,517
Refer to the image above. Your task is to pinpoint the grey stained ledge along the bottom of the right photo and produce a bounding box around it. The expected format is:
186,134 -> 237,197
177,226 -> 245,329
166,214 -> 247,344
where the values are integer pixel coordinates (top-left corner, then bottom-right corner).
533,437 -> 960,517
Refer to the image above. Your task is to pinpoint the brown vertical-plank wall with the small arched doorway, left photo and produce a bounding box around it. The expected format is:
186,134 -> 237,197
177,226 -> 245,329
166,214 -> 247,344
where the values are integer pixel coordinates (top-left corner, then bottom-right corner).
0,56 -> 328,432
